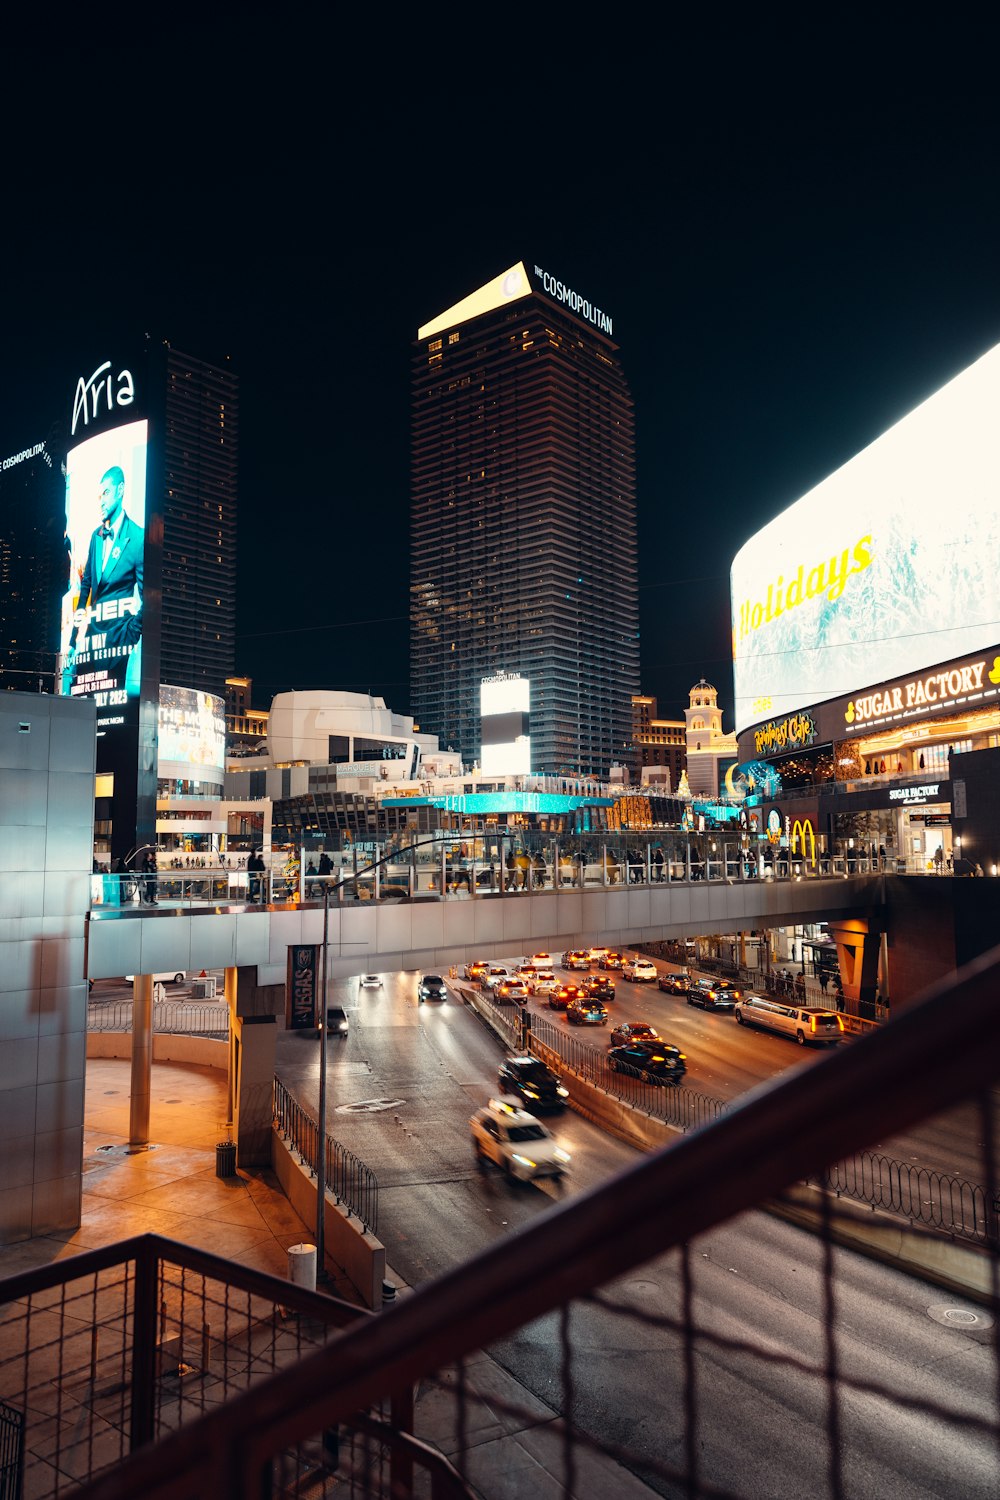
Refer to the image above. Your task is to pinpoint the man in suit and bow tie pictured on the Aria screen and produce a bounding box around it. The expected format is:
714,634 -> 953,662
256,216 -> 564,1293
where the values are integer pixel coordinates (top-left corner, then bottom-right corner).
67,464 -> 145,686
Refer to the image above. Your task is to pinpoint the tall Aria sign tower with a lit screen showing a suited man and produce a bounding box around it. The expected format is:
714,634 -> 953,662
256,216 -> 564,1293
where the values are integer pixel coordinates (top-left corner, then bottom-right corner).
58,346 -> 162,860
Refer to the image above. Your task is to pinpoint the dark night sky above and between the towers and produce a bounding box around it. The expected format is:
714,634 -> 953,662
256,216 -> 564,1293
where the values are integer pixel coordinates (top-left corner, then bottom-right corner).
7,43 -> 1000,747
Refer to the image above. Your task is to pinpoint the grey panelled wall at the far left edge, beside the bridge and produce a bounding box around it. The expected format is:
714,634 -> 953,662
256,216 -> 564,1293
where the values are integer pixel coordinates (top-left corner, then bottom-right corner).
0,693 -> 97,1245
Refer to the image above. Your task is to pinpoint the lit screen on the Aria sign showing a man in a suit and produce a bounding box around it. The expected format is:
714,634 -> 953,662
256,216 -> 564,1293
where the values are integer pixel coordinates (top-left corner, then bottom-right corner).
58,422 -> 147,735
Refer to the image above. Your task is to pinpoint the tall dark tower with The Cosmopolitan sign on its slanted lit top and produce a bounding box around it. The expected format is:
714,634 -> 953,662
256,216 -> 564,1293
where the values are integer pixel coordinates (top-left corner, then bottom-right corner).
411,263 -> 639,776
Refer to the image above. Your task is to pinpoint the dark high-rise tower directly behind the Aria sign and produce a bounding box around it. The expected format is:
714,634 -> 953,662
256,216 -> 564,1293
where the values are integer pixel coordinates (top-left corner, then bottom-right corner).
160,345 -> 240,698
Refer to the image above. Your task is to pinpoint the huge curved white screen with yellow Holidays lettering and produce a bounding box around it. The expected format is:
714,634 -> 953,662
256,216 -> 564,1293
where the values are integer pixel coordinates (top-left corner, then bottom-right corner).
732,345 -> 1000,732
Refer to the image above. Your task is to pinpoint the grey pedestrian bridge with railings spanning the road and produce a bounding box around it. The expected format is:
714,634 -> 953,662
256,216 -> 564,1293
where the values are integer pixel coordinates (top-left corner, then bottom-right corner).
87,861 -> 885,986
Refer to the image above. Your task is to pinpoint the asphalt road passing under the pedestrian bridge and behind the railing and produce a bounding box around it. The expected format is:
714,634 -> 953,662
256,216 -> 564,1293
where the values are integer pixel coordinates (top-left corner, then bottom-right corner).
279,974 -> 1000,1500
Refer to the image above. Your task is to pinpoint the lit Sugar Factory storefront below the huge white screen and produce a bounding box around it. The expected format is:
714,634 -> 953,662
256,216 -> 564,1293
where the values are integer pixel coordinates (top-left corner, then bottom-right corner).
739,648 -> 1000,873
